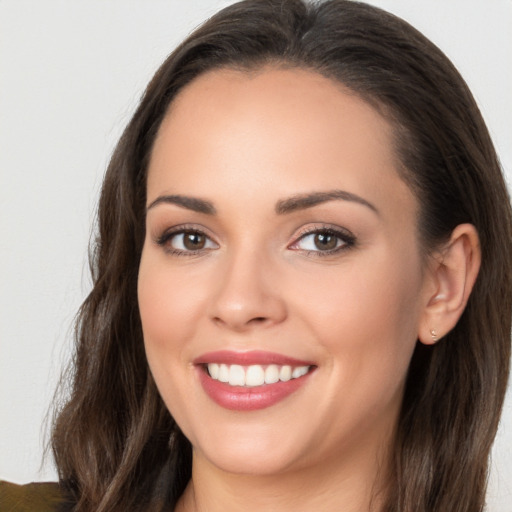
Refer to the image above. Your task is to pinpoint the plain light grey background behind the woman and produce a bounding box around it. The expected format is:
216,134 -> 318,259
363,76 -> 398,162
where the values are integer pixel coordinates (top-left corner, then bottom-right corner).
0,0 -> 512,512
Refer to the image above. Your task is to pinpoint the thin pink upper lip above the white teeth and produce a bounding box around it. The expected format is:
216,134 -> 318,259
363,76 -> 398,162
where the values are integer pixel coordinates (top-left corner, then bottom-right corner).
193,350 -> 314,366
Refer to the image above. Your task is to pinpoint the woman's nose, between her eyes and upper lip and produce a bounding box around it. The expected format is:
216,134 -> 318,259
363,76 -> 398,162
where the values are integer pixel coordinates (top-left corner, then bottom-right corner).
210,252 -> 287,332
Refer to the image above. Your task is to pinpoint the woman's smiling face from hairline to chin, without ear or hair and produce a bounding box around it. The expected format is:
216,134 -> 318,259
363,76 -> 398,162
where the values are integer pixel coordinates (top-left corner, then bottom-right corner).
138,68 -> 428,474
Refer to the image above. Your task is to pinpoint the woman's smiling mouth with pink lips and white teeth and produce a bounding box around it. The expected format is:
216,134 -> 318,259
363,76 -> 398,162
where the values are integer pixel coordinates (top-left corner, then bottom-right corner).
194,351 -> 316,411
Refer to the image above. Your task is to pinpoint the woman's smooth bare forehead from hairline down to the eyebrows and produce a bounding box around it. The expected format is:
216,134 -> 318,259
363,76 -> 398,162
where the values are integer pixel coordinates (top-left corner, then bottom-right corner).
148,67 -> 411,223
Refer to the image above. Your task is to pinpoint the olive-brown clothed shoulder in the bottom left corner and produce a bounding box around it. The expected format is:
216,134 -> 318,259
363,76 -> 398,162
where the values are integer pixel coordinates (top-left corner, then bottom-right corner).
0,481 -> 71,512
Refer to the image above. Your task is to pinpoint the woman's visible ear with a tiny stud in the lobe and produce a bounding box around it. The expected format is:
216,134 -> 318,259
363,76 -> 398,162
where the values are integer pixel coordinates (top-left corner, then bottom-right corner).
418,224 -> 481,345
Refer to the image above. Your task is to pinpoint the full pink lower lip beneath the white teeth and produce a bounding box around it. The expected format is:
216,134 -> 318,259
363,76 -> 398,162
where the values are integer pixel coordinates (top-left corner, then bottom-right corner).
198,367 -> 311,411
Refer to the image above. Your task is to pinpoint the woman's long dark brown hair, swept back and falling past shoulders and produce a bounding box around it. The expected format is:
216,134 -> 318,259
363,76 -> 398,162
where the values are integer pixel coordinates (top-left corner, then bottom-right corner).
52,0 -> 512,512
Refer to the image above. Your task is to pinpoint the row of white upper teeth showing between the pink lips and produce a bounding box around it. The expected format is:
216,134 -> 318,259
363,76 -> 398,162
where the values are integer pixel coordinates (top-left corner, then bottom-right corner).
207,363 -> 311,387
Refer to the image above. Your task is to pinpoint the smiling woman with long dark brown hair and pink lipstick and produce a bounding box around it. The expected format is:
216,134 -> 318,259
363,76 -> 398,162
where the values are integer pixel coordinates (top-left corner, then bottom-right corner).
2,0 -> 512,512
